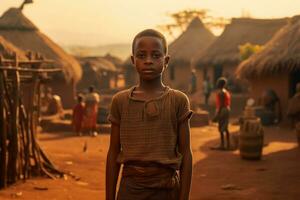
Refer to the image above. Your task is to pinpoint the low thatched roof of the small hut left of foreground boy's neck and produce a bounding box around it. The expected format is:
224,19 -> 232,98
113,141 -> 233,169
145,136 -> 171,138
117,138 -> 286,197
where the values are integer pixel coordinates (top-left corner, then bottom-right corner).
77,57 -> 118,72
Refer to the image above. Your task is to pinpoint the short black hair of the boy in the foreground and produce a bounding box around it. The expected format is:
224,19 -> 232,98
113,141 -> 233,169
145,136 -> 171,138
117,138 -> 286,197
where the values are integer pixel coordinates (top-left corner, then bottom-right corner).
132,29 -> 168,54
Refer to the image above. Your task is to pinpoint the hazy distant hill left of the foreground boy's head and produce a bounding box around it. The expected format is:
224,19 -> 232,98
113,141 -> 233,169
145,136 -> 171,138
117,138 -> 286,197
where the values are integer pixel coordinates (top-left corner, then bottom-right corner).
63,44 -> 131,60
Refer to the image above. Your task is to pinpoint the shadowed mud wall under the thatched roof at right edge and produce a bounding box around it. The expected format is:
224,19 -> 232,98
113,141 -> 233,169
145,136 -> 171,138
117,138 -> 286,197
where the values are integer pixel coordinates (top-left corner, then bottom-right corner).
249,73 -> 289,119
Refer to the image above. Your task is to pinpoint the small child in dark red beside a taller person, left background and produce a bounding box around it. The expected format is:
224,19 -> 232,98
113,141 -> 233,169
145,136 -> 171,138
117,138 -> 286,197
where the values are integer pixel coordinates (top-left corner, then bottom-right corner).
72,95 -> 85,136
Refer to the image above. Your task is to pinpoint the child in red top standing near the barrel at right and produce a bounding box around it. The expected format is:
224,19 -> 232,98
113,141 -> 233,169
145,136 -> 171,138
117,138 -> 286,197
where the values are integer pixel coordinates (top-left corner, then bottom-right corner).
215,77 -> 231,150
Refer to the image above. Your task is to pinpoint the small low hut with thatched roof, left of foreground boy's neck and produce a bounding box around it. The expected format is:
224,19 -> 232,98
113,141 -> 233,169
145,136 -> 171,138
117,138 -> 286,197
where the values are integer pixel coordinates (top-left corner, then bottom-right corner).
77,57 -> 119,91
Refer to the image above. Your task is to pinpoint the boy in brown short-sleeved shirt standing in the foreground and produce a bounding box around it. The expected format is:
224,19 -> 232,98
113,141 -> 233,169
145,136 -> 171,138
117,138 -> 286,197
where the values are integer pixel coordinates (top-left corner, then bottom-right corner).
106,29 -> 192,200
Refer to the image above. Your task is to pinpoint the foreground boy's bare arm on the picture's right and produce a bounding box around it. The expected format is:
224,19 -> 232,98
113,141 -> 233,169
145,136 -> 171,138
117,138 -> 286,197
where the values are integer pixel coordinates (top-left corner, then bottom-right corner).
179,119 -> 193,200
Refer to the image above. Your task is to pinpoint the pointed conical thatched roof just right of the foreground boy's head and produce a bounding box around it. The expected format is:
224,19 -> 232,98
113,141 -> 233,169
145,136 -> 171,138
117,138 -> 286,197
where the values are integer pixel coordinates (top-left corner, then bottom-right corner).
169,17 -> 216,65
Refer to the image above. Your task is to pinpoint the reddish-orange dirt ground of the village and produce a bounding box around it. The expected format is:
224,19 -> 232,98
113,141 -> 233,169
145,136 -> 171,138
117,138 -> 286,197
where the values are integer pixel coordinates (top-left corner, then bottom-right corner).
0,125 -> 300,200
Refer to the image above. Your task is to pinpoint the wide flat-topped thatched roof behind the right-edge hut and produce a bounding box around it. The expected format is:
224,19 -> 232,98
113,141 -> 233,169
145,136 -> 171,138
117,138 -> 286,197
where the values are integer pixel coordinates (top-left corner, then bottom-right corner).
196,18 -> 287,67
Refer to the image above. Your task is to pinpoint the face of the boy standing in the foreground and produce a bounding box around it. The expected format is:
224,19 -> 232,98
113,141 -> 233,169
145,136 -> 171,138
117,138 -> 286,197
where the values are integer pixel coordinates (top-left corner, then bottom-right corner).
131,36 -> 169,80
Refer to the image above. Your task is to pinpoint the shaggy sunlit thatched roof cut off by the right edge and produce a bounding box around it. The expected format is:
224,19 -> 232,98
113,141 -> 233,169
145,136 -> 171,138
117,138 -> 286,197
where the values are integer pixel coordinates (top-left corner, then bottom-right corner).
237,16 -> 300,78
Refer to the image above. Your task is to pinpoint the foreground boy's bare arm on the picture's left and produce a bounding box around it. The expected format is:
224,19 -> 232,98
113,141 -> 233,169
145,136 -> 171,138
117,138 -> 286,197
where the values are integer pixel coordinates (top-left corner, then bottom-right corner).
106,123 -> 121,200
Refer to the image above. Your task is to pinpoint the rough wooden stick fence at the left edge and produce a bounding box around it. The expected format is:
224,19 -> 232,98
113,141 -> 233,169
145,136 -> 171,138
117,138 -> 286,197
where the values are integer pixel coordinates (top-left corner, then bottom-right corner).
0,55 -> 63,189
